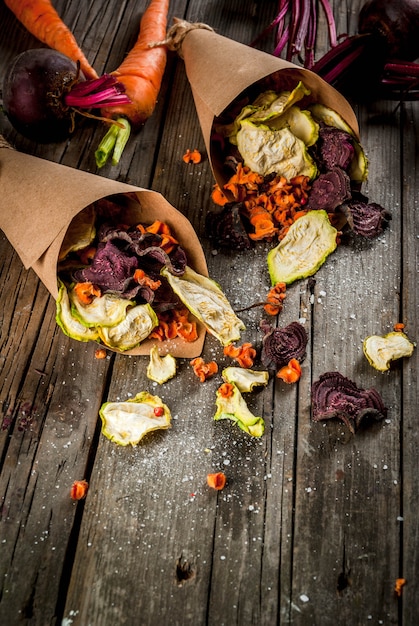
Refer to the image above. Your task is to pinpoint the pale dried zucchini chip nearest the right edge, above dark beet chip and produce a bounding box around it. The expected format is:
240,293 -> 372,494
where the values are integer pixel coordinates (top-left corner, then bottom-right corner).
363,331 -> 415,372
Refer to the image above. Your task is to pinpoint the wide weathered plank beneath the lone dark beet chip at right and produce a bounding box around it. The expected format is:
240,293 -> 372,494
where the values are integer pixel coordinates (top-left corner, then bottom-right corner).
293,98 -> 401,624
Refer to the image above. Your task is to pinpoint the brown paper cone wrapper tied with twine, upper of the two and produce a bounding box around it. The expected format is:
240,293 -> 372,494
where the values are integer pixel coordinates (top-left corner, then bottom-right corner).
182,28 -> 359,187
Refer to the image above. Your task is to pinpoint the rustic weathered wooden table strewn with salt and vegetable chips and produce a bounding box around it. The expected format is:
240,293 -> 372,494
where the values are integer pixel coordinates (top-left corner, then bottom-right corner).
0,0 -> 419,626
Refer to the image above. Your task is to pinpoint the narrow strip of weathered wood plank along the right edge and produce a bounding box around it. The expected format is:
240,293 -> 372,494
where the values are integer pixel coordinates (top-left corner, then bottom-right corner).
399,102 -> 419,624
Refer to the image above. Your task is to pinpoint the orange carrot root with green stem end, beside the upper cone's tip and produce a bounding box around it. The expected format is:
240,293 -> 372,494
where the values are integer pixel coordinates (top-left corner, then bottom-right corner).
102,0 -> 169,128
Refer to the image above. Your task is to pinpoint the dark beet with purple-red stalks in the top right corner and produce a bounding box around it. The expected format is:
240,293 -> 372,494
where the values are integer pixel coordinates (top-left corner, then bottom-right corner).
251,0 -> 419,100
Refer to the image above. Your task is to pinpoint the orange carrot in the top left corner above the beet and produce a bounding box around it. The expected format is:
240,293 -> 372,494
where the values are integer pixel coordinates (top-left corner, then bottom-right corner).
5,0 -> 97,79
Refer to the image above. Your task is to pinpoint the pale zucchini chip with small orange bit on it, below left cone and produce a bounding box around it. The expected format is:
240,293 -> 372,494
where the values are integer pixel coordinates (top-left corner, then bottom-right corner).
99,391 -> 172,446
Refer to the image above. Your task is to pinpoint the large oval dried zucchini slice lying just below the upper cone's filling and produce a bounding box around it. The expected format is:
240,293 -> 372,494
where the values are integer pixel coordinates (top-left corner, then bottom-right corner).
267,210 -> 337,285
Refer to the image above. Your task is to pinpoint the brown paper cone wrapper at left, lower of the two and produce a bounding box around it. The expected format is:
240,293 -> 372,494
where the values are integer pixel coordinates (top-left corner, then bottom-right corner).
0,147 -> 208,358
